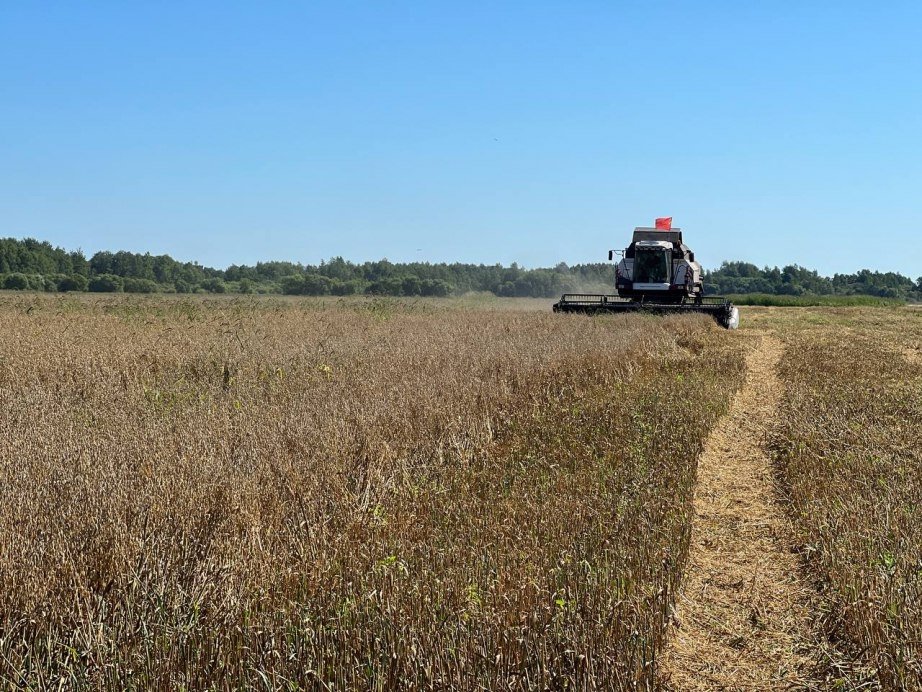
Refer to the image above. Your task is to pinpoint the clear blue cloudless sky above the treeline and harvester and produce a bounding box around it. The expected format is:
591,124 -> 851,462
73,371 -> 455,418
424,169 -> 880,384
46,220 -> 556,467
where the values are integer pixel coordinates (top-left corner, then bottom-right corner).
0,0 -> 922,278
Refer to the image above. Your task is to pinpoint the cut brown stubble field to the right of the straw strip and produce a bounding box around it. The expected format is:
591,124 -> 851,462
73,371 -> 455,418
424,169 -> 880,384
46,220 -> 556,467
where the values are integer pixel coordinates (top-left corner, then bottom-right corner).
772,310 -> 922,690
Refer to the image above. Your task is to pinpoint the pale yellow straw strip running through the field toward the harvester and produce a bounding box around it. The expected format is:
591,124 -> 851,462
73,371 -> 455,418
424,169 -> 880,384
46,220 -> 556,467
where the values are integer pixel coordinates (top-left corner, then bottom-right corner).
662,332 -> 811,690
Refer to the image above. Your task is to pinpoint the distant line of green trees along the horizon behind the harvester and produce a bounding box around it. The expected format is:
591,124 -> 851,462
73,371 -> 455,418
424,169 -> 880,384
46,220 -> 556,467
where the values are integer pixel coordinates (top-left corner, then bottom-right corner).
0,238 -> 922,301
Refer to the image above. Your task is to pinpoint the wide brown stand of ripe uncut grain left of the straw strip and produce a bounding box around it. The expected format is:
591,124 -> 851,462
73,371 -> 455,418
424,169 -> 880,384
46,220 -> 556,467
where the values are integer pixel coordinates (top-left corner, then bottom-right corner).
0,297 -> 742,689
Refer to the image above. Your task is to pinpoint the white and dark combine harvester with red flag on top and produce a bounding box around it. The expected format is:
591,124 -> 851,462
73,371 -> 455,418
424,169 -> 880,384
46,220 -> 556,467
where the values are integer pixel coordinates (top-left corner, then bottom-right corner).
554,217 -> 740,329
